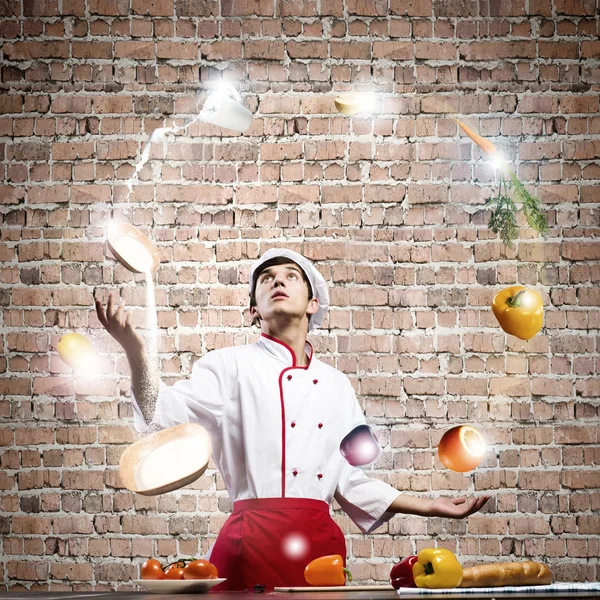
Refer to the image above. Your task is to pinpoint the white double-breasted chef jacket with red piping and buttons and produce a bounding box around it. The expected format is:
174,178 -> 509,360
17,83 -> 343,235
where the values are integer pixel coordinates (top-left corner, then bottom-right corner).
132,333 -> 399,533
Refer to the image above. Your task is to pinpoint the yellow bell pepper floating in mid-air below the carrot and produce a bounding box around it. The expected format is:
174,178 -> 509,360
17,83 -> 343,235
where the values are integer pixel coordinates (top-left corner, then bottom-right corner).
492,285 -> 544,340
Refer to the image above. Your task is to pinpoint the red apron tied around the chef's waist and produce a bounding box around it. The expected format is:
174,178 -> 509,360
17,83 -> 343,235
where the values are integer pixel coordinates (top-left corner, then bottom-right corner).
210,498 -> 346,592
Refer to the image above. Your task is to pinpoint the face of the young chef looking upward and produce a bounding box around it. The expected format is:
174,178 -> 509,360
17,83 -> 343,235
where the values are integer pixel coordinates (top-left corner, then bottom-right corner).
250,263 -> 319,324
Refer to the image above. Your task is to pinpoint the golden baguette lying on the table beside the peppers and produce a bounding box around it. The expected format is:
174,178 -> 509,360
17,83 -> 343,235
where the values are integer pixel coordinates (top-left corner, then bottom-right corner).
459,560 -> 552,587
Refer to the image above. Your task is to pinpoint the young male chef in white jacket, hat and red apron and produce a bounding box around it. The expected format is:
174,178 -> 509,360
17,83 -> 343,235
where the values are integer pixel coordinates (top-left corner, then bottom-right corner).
96,249 -> 488,590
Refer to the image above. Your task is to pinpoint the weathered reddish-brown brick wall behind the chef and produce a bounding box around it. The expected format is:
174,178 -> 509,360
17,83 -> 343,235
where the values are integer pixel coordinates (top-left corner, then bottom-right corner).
0,0 -> 600,591
